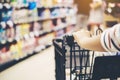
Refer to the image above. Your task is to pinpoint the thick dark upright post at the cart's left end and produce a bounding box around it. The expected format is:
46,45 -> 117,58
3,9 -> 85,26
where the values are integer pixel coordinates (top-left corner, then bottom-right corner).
53,39 -> 66,80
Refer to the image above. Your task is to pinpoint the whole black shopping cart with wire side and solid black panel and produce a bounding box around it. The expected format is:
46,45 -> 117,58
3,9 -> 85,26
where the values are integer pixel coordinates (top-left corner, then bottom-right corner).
53,35 -> 120,80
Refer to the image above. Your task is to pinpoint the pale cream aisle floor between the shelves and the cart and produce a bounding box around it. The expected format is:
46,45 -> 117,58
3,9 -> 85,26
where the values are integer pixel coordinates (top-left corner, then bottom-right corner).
0,46 -> 55,80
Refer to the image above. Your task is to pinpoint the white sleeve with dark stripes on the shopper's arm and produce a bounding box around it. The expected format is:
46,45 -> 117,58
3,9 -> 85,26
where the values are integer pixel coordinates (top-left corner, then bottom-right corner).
100,24 -> 120,52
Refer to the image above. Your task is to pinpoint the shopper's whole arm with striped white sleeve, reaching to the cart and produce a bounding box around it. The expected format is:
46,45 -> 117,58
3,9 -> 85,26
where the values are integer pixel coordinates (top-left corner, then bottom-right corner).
73,23 -> 120,52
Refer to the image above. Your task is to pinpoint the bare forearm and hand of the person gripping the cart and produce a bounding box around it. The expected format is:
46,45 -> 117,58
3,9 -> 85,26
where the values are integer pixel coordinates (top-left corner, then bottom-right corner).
73,30 -> 105,52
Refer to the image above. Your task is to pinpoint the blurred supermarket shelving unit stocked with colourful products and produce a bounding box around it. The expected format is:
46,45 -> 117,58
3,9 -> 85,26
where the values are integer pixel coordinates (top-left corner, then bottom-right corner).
0,0 -> 77,71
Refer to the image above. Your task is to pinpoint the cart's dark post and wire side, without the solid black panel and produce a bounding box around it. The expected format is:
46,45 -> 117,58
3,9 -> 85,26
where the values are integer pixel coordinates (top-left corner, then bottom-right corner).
53,36 -> 94,80
